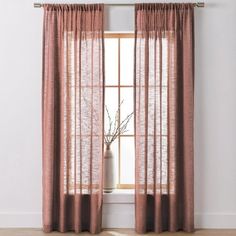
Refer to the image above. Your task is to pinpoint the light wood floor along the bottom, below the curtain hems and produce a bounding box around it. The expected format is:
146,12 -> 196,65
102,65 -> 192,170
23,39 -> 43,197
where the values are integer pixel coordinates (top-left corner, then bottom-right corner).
0,229 -> 236,236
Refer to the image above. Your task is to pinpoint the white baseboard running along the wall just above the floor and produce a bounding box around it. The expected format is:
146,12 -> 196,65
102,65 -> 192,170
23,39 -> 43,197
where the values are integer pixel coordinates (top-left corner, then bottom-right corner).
0,212 -> 236,229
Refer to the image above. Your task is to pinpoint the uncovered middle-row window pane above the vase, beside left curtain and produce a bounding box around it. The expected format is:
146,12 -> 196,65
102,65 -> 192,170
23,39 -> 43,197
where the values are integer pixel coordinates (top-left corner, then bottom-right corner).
105,88 -> 118,133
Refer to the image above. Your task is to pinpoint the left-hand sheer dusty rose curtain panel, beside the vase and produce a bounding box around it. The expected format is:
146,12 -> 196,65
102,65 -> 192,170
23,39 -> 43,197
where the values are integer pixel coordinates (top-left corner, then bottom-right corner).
43,4 -> 104,233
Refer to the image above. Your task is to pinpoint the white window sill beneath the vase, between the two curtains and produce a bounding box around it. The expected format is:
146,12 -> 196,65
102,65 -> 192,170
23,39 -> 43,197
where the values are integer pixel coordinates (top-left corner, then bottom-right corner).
103,189 -> 134,204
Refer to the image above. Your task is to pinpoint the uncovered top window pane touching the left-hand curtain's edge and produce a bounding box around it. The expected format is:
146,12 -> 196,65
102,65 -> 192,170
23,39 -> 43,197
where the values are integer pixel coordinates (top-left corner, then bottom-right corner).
105,38 -> 118,85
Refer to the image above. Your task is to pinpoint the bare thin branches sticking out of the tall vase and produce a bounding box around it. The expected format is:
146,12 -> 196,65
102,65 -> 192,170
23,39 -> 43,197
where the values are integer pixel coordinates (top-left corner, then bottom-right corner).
104,100 -> 134,146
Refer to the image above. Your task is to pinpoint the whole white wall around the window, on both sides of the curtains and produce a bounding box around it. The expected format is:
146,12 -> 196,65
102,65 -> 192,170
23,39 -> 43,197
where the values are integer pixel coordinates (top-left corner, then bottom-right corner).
0,0 -> 236,228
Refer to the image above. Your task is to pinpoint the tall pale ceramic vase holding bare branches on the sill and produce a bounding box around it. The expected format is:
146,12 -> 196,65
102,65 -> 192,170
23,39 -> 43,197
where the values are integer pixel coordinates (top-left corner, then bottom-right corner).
103,145 -> 116,193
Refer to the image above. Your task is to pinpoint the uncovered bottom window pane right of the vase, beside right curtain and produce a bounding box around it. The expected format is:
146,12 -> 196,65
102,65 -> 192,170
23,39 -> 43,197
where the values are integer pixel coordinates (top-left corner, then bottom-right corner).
120,137 -> 135,184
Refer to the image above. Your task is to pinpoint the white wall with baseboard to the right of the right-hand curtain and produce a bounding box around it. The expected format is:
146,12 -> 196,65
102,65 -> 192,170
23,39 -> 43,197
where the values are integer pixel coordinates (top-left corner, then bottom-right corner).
195,0 -> 236,228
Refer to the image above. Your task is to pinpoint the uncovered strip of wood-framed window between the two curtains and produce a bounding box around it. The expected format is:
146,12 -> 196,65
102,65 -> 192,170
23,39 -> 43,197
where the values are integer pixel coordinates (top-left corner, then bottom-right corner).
105,34 -> 135,188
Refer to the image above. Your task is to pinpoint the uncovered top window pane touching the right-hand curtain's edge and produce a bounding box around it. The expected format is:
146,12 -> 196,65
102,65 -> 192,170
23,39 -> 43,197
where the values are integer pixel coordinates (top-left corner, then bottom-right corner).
120,38 -> 134,85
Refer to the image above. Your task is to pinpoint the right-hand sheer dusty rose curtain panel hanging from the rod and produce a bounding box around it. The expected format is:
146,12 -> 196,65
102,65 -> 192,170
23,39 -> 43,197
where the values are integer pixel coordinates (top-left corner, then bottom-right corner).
135,4 -> 194,233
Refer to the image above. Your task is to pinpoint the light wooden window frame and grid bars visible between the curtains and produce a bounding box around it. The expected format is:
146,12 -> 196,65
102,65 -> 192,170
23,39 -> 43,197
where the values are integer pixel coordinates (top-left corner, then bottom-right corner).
104,33 -> 135,189
